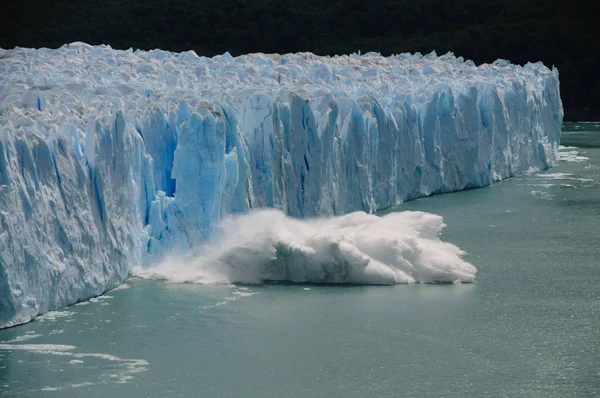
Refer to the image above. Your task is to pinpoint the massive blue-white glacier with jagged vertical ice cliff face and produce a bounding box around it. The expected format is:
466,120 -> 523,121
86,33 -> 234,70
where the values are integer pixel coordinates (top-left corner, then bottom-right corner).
0,42 -> 563,327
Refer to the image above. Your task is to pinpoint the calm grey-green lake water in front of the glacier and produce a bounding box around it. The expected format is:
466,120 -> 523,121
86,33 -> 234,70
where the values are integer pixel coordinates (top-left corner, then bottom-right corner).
0,125 -> 600,397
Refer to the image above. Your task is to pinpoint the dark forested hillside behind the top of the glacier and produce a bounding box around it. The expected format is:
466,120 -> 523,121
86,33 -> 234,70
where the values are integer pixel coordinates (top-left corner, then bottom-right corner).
0,0 -> 600,120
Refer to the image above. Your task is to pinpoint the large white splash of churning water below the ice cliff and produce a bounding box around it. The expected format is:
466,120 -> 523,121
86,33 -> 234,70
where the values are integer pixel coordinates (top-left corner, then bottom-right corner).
134,209 -> 476,285
